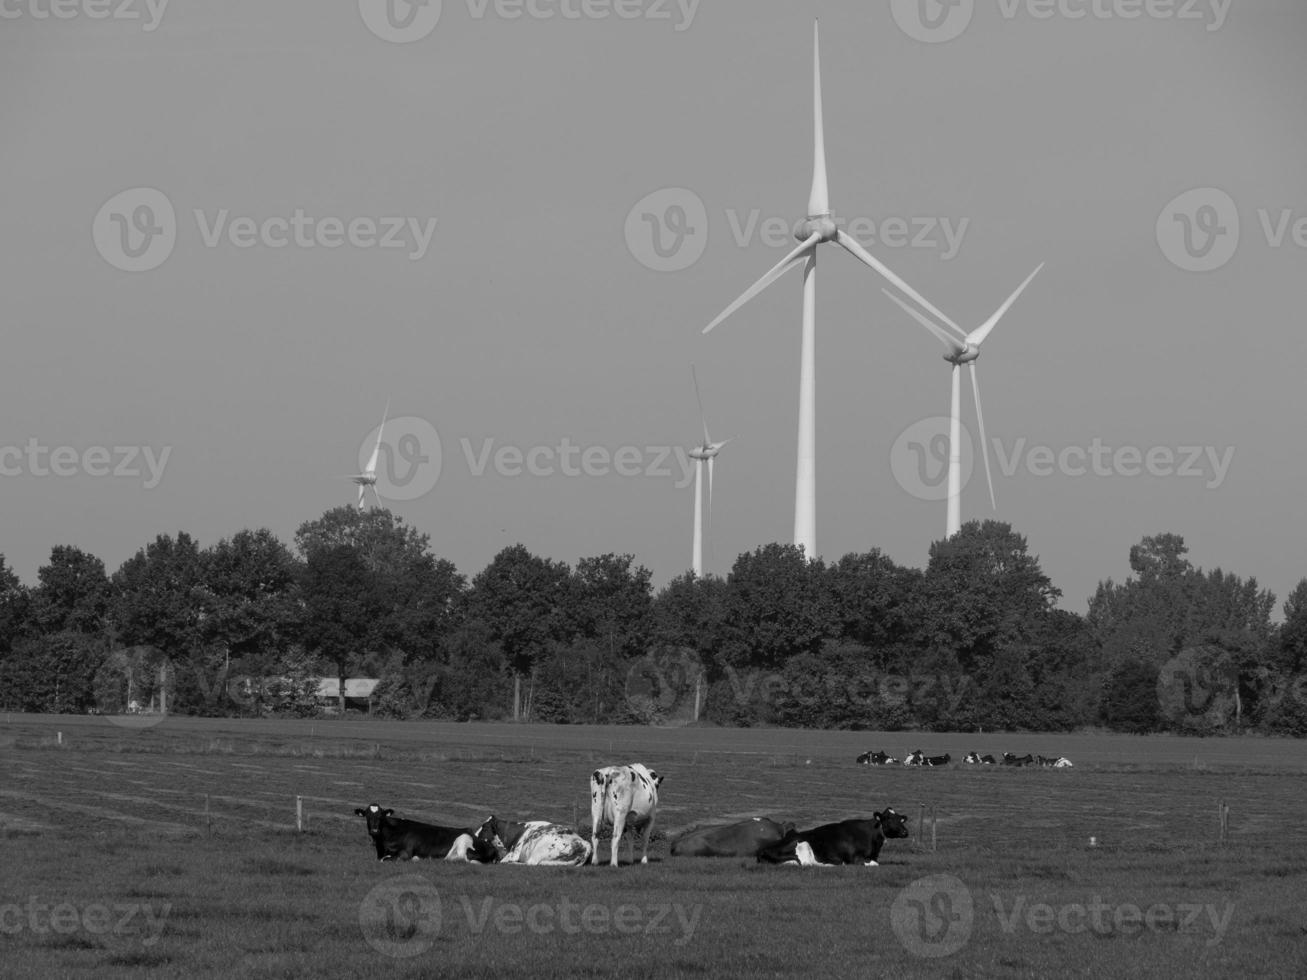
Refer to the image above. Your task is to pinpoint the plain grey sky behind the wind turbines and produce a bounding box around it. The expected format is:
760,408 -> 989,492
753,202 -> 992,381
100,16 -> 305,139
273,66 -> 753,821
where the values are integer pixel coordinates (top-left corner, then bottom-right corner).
0,0 -> 1307,615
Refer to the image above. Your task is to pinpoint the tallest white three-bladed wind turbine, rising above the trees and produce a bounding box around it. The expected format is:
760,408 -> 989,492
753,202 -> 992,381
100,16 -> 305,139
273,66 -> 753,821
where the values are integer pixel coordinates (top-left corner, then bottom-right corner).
703,22 -> 951,558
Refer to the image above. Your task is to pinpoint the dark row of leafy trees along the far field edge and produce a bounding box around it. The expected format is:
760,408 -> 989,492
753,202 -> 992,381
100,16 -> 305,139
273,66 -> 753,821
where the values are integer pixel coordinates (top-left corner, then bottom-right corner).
0,507 -> 1307,736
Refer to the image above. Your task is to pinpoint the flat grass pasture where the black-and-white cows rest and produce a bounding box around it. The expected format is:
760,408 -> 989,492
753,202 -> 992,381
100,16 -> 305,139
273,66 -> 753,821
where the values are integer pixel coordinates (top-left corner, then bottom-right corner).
0,715 -> 1307,977
